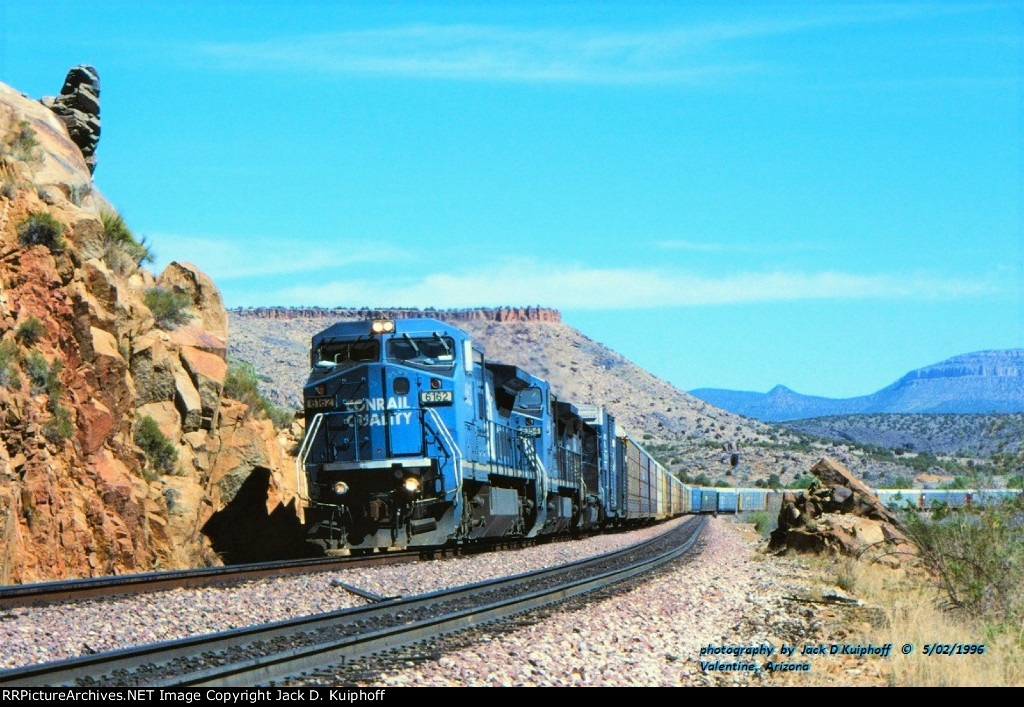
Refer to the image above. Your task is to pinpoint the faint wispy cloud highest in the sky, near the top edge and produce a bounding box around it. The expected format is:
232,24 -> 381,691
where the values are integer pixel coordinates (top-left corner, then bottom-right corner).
190,5 -> 936,84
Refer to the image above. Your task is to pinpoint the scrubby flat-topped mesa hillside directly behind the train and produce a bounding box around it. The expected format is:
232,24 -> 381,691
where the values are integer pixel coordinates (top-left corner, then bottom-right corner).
229,307 -> 925,486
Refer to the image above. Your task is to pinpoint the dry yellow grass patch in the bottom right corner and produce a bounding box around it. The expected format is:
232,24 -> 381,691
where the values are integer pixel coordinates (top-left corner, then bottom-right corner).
831,559 -> 1024,687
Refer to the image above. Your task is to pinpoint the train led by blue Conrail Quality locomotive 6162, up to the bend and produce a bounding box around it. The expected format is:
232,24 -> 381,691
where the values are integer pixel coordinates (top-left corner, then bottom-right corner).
297,319 -> 690,550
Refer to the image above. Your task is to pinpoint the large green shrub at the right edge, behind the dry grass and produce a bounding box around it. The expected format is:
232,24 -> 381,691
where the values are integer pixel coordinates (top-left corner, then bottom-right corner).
902,498 -> 1024,621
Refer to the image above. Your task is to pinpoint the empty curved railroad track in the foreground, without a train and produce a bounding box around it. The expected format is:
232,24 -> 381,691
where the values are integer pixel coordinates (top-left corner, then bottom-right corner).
0,517 -> 707,687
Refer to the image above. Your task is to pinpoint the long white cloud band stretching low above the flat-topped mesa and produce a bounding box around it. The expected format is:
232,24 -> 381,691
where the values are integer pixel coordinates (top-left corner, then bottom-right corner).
253,262 -> 1001,309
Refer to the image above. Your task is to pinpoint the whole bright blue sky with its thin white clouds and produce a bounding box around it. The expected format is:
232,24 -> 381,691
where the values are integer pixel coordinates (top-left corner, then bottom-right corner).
0,1 -> 1024,397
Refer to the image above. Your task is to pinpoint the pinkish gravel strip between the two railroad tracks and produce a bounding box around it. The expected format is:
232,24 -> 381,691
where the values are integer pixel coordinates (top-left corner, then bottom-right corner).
0,519 -> 696,669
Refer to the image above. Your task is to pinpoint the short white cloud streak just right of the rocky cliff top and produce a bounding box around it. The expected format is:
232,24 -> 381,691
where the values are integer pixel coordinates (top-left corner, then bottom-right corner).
151,229 -> 408,281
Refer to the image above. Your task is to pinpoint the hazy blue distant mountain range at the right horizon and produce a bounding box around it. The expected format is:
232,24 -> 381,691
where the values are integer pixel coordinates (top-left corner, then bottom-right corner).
689,348 -> 1024,422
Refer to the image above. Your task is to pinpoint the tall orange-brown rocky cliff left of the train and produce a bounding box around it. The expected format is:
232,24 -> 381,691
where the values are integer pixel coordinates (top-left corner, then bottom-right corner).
0,75 -> 296,583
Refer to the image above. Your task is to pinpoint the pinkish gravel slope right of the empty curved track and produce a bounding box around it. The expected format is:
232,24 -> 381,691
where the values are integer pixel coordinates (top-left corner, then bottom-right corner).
335,518 -> 817,687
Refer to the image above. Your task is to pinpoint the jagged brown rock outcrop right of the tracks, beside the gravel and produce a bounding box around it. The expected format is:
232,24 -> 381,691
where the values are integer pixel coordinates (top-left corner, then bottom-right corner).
769,458 -> 913,564
